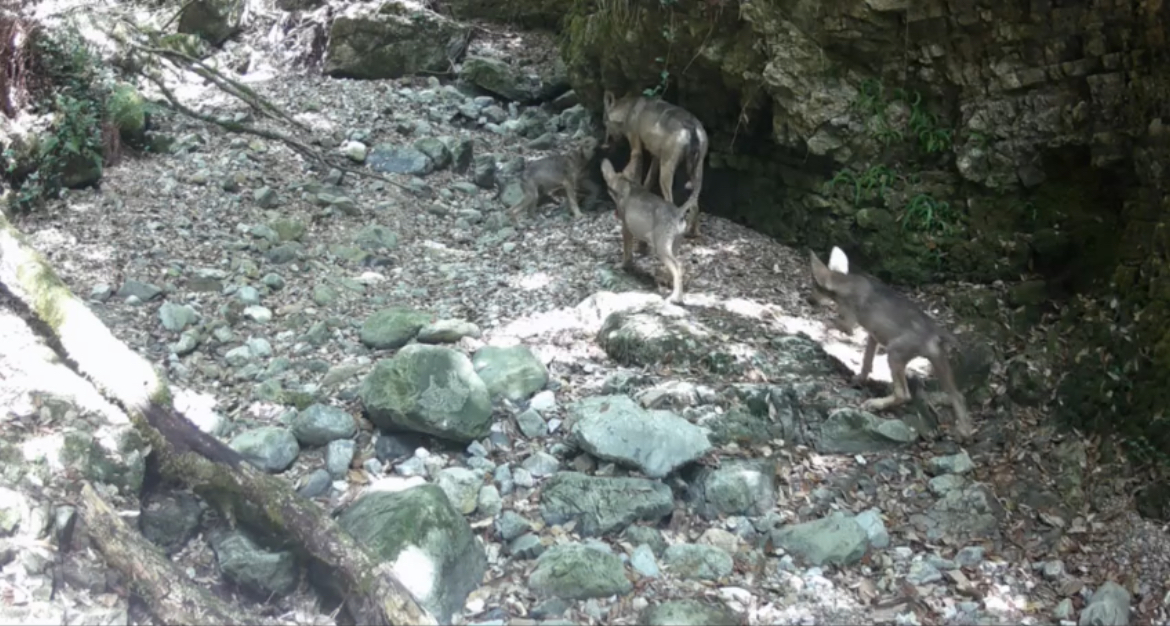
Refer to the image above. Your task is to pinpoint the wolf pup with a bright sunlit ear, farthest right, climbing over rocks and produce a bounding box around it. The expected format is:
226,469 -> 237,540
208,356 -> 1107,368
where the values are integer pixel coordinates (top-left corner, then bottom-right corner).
810,246 -> 975,439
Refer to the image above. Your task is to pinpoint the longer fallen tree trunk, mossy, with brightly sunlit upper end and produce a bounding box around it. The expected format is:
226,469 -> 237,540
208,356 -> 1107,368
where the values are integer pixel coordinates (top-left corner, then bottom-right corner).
0,214 -> 436,626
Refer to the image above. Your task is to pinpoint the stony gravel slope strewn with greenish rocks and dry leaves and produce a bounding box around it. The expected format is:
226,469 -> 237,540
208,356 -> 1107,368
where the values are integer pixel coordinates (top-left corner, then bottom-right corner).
0,0 -> 1170,624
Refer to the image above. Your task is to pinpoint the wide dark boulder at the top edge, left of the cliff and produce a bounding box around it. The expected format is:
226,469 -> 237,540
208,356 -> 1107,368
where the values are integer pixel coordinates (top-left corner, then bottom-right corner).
324,0 -> 468,78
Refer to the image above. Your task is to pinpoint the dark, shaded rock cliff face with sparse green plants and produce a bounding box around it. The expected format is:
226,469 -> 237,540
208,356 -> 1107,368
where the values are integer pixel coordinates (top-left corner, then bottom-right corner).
519,0 -> 1170,458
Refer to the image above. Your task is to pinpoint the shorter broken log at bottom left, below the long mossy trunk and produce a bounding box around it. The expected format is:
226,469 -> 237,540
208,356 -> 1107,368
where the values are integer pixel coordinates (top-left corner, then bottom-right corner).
81,482 -> 270,624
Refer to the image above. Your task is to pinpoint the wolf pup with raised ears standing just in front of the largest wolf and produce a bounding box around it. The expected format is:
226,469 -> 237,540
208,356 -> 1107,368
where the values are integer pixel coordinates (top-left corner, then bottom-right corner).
601,159 -> 687,303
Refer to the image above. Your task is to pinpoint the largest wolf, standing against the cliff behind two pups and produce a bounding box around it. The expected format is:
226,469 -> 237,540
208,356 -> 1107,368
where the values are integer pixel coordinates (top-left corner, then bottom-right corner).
604,91 -> 708,236
